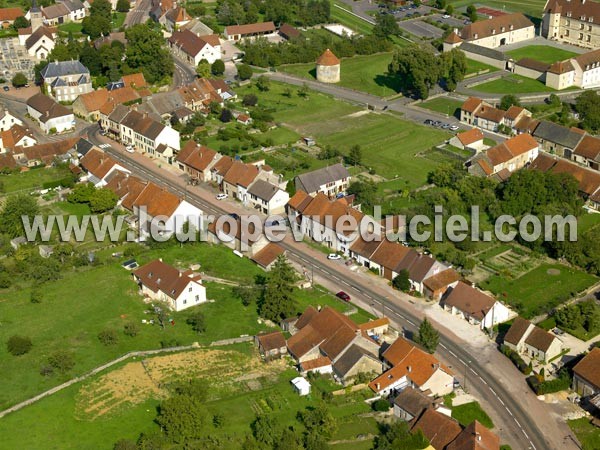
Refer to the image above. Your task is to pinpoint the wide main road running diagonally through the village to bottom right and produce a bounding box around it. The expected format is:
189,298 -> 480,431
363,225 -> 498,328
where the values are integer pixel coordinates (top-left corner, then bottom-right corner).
88,126 -> 576,450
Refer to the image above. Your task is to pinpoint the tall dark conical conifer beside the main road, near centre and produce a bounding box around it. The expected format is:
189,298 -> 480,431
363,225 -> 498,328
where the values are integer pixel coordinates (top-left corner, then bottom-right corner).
258,255 -> 297,322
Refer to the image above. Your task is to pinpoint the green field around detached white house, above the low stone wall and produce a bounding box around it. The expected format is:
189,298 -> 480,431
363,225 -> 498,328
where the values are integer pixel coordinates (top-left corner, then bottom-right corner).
0,243 -> 371,408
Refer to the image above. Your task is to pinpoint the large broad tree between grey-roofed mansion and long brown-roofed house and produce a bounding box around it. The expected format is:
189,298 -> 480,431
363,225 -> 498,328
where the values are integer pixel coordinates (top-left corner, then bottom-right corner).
125,23 -> 175,83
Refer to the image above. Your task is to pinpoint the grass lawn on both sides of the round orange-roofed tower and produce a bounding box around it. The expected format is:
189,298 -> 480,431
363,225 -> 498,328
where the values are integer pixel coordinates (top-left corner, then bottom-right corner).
278,53 -> 400,97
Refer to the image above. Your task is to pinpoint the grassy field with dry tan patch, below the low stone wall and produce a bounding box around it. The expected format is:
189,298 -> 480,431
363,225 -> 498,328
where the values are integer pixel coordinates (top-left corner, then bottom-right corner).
0,343 -> 377,450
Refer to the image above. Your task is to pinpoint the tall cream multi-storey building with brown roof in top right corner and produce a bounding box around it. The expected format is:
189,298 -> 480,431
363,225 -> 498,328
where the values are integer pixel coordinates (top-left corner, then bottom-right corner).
542,0 -> 600,48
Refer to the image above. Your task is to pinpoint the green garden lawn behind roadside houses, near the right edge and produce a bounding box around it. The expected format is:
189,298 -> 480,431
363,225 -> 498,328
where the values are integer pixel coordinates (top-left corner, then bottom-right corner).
481,264 -> 598,319
